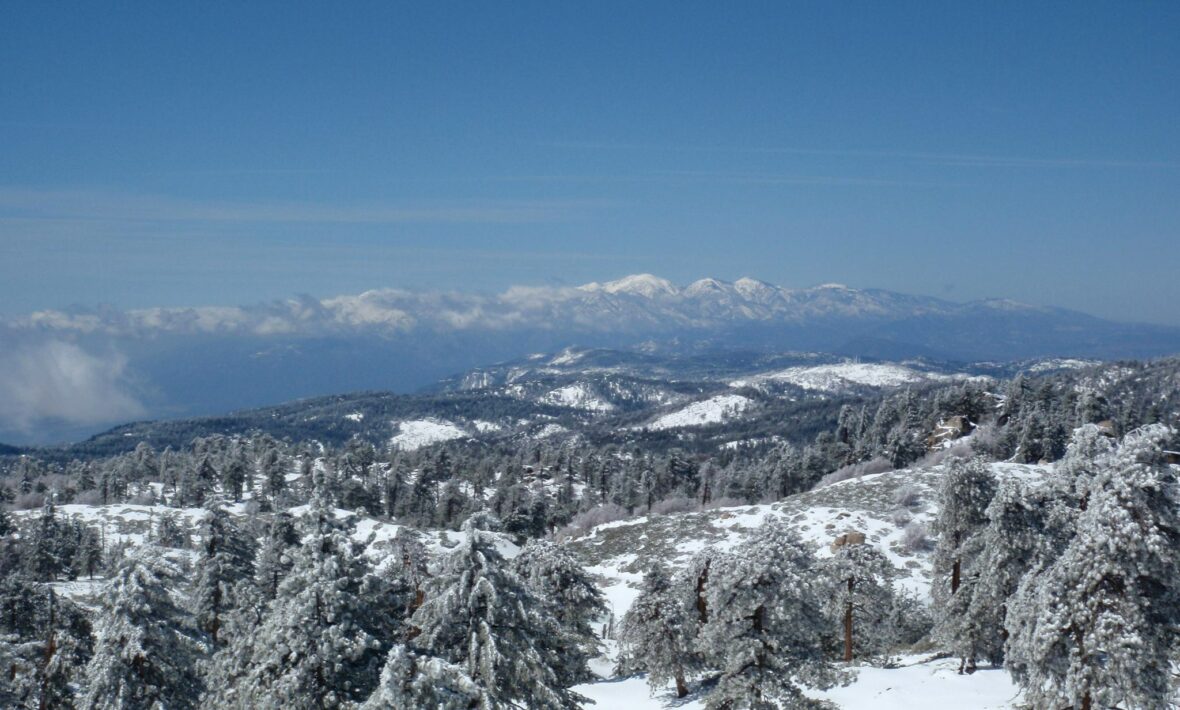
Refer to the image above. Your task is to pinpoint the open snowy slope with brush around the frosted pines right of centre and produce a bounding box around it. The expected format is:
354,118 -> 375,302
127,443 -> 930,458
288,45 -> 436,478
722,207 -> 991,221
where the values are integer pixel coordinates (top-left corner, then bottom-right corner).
570,464 -> 1049,710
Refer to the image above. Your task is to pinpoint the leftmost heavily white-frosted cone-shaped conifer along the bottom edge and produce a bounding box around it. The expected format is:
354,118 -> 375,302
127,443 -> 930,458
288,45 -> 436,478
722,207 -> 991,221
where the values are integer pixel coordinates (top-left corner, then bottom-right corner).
83,546 -> 204,710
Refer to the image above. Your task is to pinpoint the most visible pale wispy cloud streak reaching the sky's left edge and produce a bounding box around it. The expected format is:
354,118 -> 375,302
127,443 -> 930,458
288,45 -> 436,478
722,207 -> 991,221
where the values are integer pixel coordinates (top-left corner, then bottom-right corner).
0,188 -> 602,224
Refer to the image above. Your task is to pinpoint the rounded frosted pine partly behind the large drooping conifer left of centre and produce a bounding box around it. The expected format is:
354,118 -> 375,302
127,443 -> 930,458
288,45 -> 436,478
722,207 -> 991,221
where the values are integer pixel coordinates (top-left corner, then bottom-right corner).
512,540 -> 607,686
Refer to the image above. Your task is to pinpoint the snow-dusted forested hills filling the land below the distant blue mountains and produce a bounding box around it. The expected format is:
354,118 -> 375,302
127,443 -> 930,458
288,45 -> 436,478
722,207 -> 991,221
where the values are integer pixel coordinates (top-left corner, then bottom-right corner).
0,354 -> 1180,708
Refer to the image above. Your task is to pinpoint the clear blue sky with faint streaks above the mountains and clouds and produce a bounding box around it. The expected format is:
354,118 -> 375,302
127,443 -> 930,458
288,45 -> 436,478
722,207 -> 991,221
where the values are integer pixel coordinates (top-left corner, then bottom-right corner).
0,0 -> 1180,324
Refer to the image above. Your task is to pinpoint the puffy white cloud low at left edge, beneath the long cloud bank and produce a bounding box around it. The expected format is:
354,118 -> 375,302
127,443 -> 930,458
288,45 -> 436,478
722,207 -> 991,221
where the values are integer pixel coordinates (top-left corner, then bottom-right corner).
0,340 -> 145,432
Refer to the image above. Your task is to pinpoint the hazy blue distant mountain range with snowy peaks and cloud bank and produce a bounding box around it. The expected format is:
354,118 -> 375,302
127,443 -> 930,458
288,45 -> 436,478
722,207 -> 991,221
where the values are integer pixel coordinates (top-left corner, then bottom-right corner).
0,274 -> 1180,441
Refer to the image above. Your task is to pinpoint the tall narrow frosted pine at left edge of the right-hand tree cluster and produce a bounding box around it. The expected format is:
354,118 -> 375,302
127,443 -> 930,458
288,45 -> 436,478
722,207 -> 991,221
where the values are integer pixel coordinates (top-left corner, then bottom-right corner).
931,459 -> 996,671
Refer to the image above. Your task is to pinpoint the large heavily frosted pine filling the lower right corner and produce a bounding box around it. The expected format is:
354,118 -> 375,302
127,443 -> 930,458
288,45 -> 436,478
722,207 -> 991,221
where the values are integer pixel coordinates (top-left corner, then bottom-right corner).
1008,425 -> 1180,710
